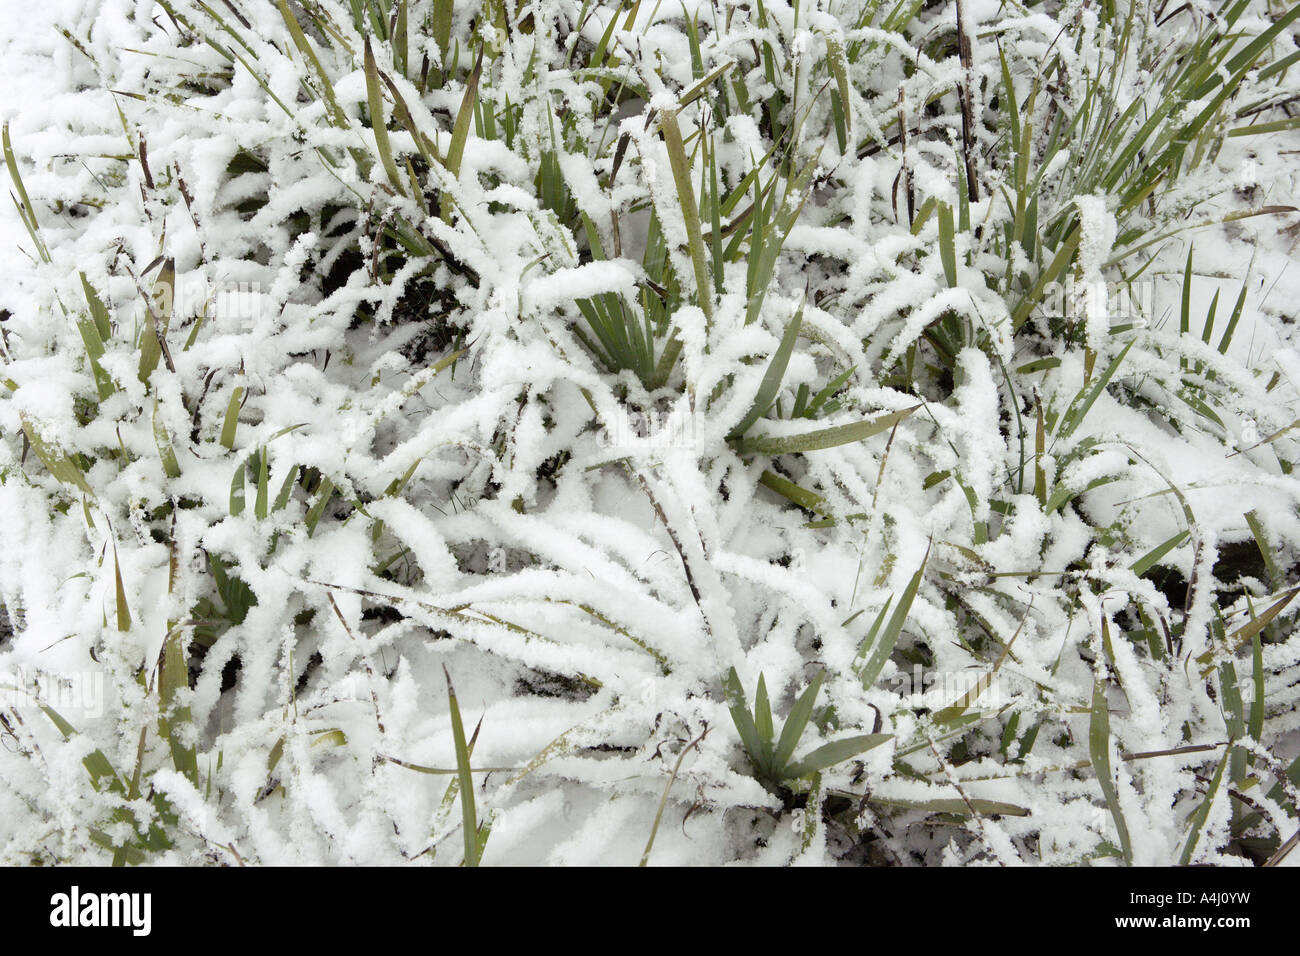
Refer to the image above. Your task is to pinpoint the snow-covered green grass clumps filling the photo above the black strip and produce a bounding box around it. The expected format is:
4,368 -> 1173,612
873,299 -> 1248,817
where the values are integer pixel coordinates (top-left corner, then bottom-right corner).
0,0 -> 1300,865
